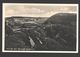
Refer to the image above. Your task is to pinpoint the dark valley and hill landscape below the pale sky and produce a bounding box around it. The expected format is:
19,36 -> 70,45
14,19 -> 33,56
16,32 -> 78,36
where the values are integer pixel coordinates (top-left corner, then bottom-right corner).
5,13 -> 76,51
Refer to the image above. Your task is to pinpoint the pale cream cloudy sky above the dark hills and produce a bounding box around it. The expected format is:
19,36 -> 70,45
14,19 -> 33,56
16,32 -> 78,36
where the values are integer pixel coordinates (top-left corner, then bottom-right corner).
3,4 -> 77,17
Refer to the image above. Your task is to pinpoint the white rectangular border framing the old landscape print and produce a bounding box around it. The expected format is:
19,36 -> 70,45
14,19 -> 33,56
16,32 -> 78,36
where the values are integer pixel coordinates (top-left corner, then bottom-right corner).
2,3 -> 79,53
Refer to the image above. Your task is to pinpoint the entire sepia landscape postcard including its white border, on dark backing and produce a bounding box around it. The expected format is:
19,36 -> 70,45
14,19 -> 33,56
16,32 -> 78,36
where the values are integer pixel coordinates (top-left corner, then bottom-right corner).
2,3 -> 79,53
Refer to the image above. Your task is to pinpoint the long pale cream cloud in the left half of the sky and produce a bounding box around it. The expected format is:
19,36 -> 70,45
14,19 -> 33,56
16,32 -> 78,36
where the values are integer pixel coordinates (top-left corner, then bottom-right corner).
5,6 -> 45,15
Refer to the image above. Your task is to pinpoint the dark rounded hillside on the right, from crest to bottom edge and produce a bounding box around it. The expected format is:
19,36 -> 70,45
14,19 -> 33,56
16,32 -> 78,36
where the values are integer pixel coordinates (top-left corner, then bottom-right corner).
44,13 -> 76,50
